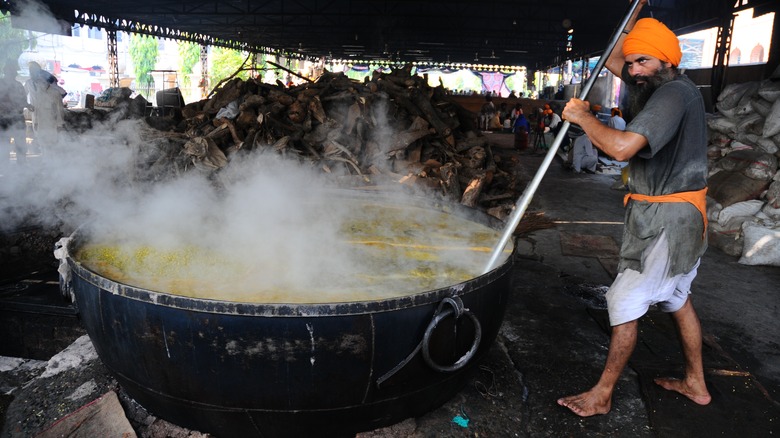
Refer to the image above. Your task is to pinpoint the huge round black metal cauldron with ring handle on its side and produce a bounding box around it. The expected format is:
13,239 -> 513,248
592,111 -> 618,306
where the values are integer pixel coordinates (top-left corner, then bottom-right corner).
62,193 -> 512,437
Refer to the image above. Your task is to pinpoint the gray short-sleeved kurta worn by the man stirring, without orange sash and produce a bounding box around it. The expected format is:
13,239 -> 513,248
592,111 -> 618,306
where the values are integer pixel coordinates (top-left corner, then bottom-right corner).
618,76 -> 707,275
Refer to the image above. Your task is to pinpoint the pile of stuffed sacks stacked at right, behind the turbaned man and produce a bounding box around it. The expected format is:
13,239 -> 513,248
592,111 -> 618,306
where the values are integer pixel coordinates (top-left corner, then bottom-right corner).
707,68 -> 780,266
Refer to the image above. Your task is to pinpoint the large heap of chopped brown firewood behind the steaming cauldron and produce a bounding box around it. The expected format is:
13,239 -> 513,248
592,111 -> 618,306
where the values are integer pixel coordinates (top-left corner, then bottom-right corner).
71,68 -> 522,218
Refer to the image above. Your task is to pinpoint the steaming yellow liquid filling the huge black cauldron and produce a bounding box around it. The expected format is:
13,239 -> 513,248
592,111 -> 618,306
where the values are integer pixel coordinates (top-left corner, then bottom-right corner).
75,204 -> 511,304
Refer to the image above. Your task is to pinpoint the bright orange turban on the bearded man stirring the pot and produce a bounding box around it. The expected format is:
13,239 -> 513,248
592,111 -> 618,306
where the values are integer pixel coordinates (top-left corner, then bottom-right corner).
623,18 -> 682,66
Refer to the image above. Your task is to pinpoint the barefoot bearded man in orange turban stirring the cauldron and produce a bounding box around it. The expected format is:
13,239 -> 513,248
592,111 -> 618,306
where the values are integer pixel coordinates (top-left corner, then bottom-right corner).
558,1 -> 711,417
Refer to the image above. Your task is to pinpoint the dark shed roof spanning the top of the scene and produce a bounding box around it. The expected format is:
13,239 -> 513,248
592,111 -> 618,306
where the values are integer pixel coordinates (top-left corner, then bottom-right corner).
2,0 -> 777,69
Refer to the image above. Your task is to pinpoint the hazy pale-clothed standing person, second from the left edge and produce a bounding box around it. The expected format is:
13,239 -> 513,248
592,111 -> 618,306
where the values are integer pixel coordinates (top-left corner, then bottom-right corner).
24,62 -> 67,153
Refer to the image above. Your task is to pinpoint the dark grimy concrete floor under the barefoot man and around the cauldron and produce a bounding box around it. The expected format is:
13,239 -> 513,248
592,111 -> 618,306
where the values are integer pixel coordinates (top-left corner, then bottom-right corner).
0,134 -> 780,438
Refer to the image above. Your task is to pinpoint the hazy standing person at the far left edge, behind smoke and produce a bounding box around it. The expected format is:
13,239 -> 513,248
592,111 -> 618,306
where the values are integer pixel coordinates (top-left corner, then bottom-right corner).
0,61 -> 27,167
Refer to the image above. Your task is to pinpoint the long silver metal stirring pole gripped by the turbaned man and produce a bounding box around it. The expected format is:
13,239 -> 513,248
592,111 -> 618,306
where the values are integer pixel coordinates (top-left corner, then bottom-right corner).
483,0 -> 640,273
